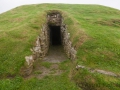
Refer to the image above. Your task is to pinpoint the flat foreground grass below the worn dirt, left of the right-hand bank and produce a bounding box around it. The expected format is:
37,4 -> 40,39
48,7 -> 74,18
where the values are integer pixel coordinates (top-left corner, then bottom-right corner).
0,61 -> 81,90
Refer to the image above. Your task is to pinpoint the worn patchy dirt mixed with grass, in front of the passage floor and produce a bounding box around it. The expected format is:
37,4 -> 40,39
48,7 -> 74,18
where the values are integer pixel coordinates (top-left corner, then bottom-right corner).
25,63 -> 64,79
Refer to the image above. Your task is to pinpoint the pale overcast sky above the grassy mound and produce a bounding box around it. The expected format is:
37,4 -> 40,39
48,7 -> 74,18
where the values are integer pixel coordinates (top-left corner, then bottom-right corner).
0,0 -> 120,13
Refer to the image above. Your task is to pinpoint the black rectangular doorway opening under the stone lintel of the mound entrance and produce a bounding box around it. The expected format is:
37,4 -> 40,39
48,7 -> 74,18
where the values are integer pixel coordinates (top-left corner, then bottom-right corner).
49,26 -> 61,45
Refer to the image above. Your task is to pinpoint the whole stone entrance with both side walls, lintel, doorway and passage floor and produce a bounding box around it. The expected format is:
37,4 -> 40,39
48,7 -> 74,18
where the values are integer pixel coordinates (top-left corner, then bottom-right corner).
23,10 -> 77,75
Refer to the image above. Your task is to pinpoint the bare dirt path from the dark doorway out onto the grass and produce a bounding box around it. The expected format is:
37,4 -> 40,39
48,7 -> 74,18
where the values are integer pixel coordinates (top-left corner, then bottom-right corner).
25,46 -> 67,79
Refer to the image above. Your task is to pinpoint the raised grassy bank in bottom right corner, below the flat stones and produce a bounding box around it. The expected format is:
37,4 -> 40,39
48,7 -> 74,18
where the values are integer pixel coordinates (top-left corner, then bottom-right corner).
73,69 -> 120,90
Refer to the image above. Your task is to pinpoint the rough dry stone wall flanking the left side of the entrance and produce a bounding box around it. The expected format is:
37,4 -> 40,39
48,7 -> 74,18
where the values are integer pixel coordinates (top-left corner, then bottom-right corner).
24,24 -> 50,75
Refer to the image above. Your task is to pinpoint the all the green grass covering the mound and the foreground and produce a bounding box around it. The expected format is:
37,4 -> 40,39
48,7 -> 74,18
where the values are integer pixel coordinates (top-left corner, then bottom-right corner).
0,4 -> 120,90
